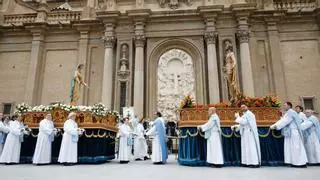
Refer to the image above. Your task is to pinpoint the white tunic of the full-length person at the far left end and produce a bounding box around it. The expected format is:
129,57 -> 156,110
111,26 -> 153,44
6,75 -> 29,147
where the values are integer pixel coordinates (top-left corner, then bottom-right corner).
0,121 -> 23,163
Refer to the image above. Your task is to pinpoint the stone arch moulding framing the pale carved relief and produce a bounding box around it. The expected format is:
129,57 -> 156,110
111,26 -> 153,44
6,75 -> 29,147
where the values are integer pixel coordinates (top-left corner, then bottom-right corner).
145,38 -> 206,117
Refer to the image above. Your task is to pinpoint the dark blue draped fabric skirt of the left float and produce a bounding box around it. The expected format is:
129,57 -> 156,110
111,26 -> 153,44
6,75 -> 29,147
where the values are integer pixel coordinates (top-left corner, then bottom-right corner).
20,129 -> 116,164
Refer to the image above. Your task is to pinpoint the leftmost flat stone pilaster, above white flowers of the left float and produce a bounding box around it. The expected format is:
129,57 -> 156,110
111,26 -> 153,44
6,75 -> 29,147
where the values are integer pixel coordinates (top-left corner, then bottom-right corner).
24,26 -> 45,105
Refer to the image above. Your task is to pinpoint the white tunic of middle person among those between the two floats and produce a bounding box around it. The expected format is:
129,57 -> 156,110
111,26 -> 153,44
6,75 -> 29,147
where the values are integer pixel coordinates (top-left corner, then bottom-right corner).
134,124 -> 148,159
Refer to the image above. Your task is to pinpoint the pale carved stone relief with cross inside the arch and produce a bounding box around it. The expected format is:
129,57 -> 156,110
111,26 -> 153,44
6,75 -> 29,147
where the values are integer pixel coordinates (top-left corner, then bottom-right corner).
157,49 -> 195,121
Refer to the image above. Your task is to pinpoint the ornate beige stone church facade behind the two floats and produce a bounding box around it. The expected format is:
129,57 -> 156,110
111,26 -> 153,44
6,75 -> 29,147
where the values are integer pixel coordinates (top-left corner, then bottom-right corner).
0,0 -> 320,119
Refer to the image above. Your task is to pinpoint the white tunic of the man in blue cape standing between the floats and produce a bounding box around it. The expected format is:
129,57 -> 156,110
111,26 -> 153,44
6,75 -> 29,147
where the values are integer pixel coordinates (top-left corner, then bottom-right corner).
146,126 -> 162,162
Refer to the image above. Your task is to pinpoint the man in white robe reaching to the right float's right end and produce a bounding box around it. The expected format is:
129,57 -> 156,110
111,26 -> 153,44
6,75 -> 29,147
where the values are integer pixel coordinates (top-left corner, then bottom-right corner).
270,102 -> 308,167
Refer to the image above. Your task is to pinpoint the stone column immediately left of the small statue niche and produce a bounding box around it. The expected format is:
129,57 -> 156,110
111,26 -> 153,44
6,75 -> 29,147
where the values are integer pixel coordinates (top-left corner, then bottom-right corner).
102,23 -> 116,108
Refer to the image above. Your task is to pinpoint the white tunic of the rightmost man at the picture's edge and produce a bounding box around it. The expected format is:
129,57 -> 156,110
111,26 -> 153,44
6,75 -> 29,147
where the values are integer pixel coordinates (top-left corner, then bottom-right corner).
301,116 -> 320,164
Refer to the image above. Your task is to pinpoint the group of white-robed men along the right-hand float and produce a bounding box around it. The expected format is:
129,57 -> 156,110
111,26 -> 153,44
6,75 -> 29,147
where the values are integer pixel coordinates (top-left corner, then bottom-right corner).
198,102 -> 320,167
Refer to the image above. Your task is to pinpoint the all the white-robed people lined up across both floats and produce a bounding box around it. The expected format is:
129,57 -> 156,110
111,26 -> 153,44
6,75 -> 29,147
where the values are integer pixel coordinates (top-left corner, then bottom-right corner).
0,102 -> 320,167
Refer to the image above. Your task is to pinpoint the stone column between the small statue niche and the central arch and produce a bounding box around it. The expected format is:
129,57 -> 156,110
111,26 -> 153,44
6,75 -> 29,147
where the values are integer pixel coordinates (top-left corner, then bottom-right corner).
133,22 -> 146,117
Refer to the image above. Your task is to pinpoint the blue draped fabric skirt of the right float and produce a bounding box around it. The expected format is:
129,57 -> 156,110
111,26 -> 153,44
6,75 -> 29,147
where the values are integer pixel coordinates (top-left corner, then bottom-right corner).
178,128 -> 284,166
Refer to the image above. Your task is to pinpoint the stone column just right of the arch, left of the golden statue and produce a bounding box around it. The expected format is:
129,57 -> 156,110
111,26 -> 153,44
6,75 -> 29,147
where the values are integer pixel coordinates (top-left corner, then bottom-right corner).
204,20 -> 220,104
